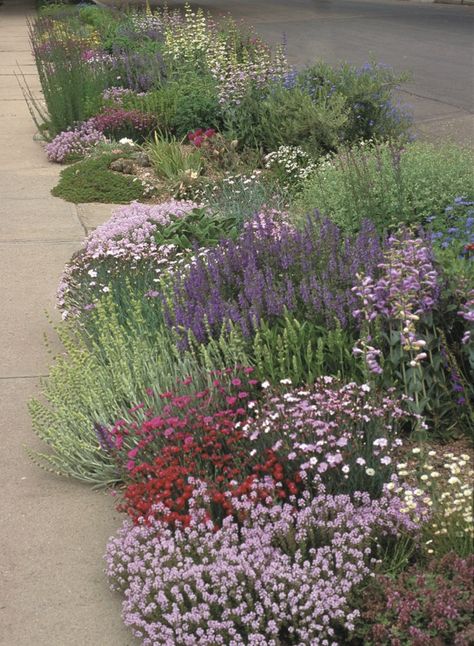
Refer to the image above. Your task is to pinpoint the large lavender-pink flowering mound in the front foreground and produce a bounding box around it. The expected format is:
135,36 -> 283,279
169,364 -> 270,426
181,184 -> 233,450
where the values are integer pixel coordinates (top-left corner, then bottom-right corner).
106,483 -> 426,646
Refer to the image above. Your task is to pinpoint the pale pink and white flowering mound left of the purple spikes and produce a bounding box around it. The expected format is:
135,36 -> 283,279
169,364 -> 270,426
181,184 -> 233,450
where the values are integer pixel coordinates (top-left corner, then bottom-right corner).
58,200 -> 244,317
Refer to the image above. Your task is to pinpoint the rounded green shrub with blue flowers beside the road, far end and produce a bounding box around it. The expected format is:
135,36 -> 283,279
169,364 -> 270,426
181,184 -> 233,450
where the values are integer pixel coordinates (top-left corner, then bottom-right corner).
226,63 -> 411,156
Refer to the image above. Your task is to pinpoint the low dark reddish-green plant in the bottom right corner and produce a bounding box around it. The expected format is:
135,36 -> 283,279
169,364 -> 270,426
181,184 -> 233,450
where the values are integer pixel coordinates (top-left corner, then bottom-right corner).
356,554 -> 474,646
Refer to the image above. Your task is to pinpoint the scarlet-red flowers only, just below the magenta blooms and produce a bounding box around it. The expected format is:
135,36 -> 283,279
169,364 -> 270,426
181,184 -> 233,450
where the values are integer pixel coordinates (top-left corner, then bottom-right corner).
119,432 -> 300,528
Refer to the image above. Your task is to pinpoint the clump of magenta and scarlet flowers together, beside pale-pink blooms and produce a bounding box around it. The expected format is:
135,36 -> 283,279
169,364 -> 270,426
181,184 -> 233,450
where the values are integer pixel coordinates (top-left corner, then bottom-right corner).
111,368 -> 301,527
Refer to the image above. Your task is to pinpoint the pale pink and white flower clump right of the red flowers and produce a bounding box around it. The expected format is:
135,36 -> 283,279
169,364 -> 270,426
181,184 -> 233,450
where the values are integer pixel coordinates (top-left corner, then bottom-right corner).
244,376 -> 411,491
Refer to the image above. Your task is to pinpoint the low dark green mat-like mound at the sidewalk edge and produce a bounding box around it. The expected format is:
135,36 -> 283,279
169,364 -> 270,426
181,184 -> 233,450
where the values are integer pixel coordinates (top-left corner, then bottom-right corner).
51,154 -> 145,204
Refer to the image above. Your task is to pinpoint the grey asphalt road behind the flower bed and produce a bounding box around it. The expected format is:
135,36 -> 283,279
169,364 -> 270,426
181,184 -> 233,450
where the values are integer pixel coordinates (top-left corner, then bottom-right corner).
126,0 -> 474,143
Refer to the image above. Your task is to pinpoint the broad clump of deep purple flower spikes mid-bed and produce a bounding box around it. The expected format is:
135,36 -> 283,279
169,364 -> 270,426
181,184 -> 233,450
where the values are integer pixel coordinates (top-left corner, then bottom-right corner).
163,214 -> 382,345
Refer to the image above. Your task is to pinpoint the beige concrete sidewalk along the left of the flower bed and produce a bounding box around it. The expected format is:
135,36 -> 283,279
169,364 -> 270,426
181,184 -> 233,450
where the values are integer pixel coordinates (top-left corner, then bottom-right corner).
0,0 -> 134,646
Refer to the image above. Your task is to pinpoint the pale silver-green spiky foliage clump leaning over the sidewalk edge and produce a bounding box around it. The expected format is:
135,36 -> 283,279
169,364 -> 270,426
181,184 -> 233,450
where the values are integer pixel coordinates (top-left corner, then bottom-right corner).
29,295 -> 205,486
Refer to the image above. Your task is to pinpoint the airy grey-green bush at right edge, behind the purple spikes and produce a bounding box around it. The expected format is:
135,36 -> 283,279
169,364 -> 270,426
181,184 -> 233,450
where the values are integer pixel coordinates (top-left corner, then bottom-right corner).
295,142 -> 474,232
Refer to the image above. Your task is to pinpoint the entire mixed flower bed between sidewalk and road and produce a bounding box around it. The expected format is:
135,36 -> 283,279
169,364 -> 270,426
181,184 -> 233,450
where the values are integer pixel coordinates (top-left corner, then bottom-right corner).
30,5 -> 474,646
